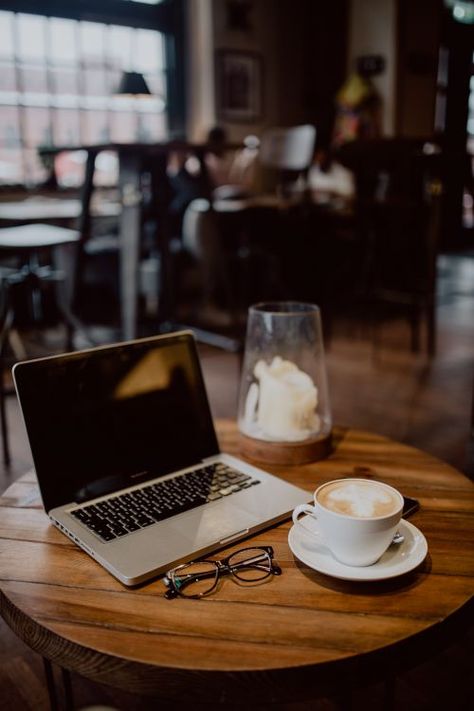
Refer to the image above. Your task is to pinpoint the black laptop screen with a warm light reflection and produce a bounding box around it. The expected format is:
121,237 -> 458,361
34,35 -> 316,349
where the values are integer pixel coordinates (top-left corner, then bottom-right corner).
14,333 -> 219,511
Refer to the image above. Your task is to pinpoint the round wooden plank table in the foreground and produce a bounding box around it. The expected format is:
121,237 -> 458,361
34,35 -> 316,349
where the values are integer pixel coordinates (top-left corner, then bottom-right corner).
0,422 -> 474,707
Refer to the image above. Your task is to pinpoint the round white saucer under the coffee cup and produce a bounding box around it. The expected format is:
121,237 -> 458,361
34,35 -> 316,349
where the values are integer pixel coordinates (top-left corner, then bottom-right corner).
288,516 -> 428,580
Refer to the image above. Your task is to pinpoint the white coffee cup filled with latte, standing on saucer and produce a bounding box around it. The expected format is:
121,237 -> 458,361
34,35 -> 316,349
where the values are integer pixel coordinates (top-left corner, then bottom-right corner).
293,478 -> 403,566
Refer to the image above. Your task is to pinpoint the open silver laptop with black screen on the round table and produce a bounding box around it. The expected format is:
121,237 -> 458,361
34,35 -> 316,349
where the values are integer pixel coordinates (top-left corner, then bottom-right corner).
13,331 -> 310,585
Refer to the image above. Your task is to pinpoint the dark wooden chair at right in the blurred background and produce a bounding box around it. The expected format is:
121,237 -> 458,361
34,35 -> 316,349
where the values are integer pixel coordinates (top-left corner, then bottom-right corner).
338,138 -> 441,356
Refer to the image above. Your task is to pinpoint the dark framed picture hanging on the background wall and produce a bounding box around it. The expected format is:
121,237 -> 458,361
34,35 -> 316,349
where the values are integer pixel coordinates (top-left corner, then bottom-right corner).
215,49 -> 263,123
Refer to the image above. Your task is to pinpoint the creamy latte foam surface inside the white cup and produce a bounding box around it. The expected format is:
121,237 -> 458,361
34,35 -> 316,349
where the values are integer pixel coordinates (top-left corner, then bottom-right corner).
318,481 -> 400,518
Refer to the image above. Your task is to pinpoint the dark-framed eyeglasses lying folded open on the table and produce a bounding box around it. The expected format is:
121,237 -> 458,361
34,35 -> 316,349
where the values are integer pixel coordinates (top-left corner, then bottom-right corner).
163,546 -> 281,600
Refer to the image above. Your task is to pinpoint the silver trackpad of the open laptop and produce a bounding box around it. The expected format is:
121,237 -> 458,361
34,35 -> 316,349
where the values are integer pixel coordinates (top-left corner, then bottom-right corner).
172,501 -> 257,548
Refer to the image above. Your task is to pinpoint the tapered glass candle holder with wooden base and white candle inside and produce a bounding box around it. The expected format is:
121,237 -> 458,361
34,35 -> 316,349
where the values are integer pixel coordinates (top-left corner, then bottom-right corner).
238,301 -> 332,464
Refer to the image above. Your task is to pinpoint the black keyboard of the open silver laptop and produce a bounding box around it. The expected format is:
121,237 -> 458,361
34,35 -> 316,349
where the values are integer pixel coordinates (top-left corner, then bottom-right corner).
70,462 -> 260,541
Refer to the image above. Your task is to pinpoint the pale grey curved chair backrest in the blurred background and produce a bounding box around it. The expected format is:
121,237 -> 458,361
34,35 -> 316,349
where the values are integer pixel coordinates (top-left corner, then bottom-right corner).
259,124 -> 316,171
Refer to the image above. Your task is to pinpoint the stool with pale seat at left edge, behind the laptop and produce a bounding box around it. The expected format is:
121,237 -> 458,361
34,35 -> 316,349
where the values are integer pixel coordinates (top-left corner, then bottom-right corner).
0,224 -> 80,466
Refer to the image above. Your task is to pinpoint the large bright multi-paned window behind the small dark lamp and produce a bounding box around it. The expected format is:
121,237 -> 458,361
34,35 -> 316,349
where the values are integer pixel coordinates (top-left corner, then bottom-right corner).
0,10 -> 167,184
